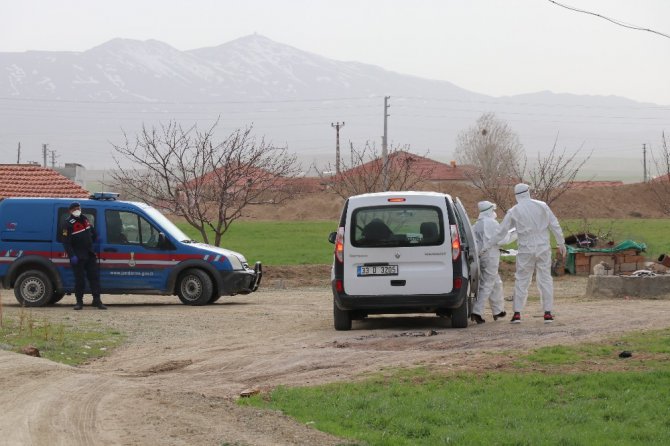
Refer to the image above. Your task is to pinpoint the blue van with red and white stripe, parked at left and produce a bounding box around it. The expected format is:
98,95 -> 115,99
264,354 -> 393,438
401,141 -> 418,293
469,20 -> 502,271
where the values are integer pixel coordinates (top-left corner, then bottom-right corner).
0,193 -> 262,307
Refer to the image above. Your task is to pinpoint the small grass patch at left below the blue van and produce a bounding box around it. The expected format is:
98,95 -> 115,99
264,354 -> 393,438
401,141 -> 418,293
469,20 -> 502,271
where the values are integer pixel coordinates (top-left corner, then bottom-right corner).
0,309 -> 125,365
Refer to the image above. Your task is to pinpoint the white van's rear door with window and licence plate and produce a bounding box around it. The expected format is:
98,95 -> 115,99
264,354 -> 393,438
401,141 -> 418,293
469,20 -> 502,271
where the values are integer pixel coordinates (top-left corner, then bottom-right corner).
343,194 -> 453,295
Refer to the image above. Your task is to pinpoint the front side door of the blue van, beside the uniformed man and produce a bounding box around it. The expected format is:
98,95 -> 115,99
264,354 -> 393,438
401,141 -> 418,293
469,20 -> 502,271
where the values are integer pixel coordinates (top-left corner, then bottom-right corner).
100,208 -> 177,292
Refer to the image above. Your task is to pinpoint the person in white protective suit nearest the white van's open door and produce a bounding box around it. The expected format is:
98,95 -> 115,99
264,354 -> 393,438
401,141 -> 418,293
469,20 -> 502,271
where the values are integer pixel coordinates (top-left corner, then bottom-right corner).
470,201 -> 516,324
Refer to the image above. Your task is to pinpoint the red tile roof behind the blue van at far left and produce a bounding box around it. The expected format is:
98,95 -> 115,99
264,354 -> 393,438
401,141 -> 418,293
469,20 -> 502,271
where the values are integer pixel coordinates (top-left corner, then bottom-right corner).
0,164 -> 89,199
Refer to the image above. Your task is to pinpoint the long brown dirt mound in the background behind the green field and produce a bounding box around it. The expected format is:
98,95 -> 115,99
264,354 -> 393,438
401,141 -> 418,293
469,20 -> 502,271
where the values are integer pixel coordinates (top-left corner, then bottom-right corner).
244,183 -> 664,221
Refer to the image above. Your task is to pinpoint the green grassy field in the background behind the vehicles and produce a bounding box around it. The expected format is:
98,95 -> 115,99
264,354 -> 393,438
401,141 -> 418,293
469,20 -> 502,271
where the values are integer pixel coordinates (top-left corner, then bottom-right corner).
179,219 -> 670,265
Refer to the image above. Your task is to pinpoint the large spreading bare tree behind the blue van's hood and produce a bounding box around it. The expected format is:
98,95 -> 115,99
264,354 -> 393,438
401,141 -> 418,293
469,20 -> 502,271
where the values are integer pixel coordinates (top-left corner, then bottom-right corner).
113,121 -> 297,246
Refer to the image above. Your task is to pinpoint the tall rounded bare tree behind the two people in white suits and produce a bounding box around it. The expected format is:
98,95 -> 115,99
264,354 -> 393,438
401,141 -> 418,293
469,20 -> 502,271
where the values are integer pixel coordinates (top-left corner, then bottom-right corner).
455,113 -> 525,210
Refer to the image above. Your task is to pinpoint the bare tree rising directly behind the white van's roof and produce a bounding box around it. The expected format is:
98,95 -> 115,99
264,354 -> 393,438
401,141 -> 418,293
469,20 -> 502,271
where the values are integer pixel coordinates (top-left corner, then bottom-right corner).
319,143 -> 430,198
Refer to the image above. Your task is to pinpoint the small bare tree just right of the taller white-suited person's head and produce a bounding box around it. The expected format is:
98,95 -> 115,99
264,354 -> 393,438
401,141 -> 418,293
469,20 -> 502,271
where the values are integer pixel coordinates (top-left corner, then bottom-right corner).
527,135 -> 593,204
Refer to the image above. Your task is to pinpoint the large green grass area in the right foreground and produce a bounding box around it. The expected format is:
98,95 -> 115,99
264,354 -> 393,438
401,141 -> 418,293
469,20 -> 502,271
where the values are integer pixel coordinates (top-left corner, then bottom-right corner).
240,330 -> 670,446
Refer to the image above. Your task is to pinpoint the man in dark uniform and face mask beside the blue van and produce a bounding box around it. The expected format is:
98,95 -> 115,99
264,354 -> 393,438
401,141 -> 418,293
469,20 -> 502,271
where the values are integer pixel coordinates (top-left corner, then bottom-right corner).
62,202 -> 107,310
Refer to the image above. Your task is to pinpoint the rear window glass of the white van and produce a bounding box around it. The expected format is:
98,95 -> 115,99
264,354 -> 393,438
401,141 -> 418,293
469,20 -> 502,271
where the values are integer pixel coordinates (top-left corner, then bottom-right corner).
350,205 -> 444,247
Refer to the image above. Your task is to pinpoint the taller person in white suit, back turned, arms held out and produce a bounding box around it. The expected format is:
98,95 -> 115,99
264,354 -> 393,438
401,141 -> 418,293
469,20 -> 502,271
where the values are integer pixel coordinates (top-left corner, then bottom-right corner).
483,183 -> 566,323
